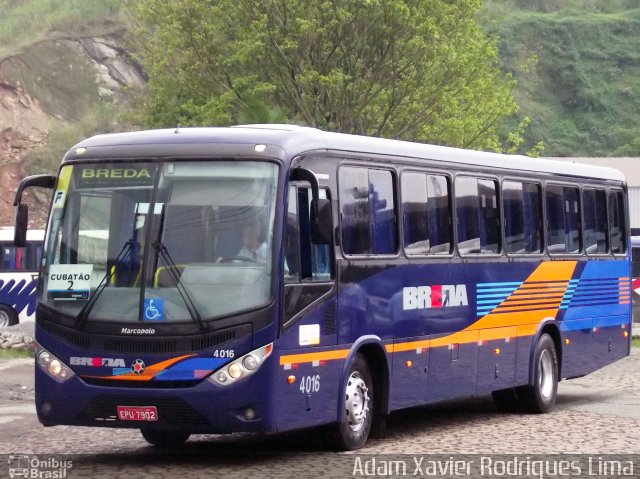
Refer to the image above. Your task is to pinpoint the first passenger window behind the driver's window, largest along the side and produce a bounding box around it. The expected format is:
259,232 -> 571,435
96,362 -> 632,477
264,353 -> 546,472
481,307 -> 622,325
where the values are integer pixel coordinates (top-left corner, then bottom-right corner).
340,167 -> 398,254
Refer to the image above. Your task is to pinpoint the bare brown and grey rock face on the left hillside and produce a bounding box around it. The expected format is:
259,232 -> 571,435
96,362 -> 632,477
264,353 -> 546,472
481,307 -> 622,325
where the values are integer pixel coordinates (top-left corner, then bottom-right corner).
0,34 -> 145,227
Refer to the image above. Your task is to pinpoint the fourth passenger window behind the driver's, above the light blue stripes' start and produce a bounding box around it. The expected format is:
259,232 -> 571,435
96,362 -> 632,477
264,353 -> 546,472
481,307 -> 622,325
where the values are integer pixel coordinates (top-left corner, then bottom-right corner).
502,181 -> 542,253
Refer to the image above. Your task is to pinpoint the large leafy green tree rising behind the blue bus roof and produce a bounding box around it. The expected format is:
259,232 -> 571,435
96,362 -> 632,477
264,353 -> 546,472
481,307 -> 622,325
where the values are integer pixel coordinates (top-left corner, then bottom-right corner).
131,0 -> 518,150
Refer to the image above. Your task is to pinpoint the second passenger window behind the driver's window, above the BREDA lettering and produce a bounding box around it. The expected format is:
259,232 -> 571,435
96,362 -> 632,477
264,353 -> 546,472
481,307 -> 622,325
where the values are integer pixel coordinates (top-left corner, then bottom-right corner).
402,173 -> 451,255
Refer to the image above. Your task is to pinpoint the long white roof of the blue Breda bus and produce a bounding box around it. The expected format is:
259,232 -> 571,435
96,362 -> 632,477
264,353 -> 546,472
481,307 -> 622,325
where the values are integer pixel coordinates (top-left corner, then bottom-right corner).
65,125 -> 625,182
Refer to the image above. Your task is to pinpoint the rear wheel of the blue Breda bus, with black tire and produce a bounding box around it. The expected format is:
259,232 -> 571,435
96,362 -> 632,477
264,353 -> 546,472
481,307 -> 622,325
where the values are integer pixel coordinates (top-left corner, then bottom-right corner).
516,333 -> 558,414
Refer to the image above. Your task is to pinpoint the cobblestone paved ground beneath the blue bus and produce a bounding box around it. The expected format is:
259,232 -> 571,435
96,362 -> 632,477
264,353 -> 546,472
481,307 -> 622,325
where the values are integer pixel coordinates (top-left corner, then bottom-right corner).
0,348 -> 640,479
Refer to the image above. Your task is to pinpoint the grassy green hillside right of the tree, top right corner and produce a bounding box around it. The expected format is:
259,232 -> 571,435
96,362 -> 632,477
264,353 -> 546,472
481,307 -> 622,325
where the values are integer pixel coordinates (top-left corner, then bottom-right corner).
482,0 -> 640,156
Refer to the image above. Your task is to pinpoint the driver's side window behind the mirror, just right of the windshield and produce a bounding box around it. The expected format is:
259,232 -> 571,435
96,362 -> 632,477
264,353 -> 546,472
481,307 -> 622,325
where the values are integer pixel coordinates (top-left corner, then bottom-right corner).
283,186 -> 331,283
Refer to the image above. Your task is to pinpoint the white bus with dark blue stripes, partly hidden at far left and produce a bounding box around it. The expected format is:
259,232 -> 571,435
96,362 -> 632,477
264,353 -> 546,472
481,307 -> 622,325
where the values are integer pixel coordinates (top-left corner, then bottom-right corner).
0,227 -> 44,327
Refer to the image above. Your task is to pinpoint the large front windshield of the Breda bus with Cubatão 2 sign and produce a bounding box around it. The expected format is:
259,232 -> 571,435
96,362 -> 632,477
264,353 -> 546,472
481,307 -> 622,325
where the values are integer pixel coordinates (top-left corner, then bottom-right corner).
40,161 -> 278,325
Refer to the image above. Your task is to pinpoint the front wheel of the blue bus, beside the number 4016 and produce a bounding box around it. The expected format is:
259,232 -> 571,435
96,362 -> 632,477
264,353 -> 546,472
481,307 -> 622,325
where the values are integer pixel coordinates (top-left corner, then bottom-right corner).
333,353 -> 375,451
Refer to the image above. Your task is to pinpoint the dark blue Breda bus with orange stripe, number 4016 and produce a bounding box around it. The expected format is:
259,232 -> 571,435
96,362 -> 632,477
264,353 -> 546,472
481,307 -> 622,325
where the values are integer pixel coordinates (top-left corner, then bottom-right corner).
15,125 -> 631,449
